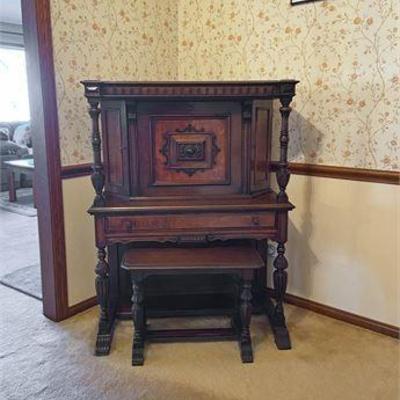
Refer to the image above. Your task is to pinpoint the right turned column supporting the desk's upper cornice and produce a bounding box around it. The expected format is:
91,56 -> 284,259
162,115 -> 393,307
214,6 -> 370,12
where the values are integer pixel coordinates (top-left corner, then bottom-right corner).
276,96 -> 292,202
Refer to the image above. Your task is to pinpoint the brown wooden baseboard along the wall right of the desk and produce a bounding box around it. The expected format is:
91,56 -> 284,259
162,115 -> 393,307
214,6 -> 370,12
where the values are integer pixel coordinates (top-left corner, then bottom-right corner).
285,294 -> 400,339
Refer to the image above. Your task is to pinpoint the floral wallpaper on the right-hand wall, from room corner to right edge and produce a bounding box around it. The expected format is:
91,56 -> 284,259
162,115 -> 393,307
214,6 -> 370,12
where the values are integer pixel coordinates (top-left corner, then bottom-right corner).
178,0 -> 400,170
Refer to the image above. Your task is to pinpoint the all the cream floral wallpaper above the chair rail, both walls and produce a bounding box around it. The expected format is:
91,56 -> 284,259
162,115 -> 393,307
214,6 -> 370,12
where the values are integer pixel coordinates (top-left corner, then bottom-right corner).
51,0 -> 400,170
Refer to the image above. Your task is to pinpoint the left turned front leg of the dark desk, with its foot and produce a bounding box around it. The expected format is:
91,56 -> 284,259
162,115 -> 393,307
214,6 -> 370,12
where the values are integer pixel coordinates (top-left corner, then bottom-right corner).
96,246 -> 114,356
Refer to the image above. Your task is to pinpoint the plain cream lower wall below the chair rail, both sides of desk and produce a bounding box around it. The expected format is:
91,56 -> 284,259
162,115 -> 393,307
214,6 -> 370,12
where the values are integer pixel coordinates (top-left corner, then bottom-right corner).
63,175 -> 400,325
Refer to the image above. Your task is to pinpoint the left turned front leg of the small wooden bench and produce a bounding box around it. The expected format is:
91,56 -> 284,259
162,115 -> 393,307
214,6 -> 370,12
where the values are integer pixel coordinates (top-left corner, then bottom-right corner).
131,273 -> 146,365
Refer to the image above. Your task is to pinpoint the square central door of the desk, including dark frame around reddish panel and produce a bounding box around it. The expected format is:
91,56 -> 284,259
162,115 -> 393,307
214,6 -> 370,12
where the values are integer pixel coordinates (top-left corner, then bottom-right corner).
137,102 -> 243,196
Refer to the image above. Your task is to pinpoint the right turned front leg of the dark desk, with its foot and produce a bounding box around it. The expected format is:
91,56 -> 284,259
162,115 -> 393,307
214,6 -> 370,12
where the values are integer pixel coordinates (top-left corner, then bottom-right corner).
268,242 -> 291,350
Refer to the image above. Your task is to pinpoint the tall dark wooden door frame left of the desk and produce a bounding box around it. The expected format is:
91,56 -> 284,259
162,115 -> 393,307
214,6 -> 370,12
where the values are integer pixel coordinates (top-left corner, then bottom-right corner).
21,0 -> 70,321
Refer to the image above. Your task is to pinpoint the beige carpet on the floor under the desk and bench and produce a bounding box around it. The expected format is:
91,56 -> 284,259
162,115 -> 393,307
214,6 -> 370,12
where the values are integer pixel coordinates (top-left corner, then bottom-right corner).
0,287 -> 399,400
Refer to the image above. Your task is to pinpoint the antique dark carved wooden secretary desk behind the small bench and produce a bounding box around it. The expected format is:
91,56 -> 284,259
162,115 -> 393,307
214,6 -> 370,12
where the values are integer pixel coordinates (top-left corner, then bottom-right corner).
82,80 -> 298,355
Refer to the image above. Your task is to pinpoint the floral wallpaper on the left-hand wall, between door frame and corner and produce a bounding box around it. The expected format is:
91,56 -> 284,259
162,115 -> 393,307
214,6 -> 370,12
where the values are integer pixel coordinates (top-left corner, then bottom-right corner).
51,0 -> 178,165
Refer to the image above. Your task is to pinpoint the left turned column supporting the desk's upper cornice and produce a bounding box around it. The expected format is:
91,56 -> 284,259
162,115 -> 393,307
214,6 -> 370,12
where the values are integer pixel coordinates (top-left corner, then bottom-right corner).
89,99 -> 104,206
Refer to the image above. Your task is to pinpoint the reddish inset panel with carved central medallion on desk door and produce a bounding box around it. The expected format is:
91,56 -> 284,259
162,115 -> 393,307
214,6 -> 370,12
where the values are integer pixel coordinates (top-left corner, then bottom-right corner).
151,116 -> 231,185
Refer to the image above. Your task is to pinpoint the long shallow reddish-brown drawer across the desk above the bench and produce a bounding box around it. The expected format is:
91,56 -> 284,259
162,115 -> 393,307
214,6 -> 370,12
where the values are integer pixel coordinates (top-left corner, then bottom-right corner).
105,212 -> 275,235
